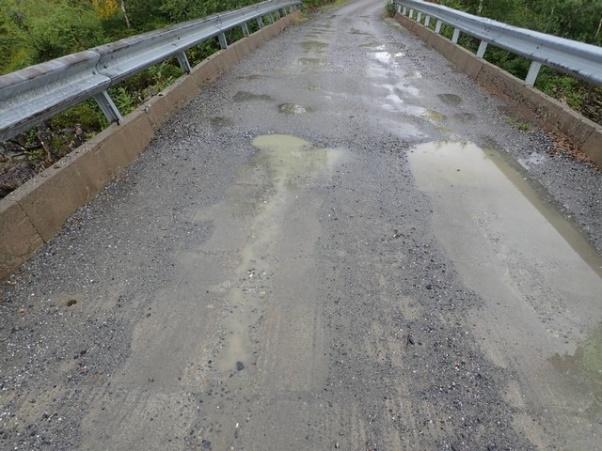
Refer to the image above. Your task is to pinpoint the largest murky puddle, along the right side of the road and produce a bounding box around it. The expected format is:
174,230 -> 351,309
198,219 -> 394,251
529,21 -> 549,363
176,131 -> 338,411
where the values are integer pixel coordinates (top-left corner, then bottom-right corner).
408,141 -> 602,440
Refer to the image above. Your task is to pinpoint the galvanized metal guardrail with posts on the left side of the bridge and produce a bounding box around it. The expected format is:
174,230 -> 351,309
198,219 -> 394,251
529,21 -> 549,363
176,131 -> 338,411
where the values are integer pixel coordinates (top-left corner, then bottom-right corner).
0,0 -> 301,141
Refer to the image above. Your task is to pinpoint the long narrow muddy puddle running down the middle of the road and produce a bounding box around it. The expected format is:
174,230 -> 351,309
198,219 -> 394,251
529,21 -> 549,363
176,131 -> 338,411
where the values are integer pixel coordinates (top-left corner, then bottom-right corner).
212,135 -> 343,374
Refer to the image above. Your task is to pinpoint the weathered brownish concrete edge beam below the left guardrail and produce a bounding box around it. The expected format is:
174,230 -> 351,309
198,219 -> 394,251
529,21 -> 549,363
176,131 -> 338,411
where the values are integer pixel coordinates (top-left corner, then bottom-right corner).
0,11 -> 300,280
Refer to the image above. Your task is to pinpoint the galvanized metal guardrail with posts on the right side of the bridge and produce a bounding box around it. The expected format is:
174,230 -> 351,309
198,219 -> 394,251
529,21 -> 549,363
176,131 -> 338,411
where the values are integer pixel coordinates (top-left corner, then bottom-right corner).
394,0 -> 602,86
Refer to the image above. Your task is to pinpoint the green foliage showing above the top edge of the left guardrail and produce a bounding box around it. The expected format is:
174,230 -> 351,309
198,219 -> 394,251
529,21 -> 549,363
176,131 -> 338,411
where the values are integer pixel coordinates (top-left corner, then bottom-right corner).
0,0 -> 268,73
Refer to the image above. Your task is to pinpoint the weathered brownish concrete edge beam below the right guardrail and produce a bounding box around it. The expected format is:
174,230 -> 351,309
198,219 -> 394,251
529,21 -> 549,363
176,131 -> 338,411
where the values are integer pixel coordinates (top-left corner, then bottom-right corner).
395,14 -> 602,168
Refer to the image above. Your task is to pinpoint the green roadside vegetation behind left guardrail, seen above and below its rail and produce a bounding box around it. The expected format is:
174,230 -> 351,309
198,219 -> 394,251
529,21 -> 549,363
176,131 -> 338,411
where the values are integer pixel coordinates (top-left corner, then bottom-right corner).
0,0 -> 272,198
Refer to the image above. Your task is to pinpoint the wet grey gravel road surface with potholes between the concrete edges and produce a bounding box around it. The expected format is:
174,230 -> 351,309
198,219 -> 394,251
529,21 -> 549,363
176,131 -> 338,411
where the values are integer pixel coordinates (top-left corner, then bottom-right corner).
0,0 -> 602,450
